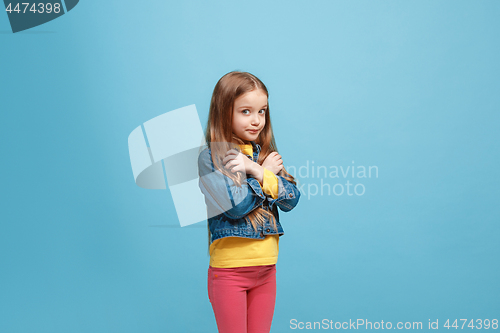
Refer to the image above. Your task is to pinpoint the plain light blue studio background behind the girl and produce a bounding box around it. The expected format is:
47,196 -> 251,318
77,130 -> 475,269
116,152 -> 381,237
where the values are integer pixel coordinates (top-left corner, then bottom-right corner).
0,0 -> 500,333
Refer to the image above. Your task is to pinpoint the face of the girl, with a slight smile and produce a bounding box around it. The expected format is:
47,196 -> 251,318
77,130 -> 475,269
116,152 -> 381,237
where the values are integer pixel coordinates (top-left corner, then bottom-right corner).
232,89 -> 267,142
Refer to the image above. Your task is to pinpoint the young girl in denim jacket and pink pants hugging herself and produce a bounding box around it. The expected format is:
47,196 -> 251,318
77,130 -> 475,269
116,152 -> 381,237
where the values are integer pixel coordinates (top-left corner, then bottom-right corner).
198,71 -> 300,333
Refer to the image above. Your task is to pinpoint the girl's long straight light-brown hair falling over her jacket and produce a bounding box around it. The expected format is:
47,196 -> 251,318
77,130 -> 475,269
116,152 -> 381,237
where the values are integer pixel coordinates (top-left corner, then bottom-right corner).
205,71 -> 297,253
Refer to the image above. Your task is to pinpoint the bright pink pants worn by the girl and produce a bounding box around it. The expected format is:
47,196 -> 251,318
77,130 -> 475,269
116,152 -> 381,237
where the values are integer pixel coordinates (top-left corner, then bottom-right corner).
208,265 -> 276,333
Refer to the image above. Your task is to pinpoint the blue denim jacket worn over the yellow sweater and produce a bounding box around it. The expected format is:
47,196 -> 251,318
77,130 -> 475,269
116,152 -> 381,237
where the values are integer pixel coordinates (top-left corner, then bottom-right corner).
198,141 -> 300,242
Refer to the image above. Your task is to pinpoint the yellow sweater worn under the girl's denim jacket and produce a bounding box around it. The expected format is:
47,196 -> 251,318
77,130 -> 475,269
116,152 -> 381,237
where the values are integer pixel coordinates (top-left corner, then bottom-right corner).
210,144 -> 279,268
